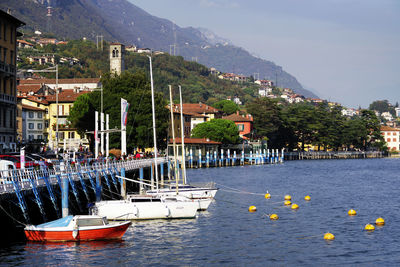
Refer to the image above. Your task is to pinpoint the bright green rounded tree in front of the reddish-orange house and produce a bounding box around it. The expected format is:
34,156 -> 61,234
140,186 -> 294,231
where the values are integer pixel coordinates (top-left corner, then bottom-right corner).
192,119 -> 240,144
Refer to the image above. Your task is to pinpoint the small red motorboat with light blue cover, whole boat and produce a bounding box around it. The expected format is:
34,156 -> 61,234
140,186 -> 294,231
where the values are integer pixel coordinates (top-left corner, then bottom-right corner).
24,215 -> 132,242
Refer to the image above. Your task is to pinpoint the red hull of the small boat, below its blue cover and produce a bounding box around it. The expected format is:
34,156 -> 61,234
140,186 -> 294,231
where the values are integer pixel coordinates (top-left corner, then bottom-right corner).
25,222 -> 131,242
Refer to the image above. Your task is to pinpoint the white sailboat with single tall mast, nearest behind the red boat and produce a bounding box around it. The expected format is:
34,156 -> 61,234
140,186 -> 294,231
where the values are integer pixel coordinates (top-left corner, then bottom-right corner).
90,57 -> 200,220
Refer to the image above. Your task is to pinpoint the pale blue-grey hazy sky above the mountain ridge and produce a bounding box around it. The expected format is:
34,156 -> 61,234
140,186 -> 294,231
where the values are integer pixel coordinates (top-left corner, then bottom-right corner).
129,0 -> 400,108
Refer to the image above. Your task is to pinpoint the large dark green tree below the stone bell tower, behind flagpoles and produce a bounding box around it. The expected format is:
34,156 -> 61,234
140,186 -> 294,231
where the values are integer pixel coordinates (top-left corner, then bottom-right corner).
70,72 -> 169,152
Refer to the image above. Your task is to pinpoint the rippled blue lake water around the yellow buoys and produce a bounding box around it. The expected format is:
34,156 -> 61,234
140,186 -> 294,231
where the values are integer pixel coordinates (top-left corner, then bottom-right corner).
0,159 -> 400,266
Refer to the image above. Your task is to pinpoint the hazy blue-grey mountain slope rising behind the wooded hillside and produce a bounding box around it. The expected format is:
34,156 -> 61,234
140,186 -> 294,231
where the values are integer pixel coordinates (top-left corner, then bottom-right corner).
0,0 -> 316,97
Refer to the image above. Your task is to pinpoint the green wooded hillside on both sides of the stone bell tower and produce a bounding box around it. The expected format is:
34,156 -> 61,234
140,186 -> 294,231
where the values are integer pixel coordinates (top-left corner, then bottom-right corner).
18,40 -> 258,104
